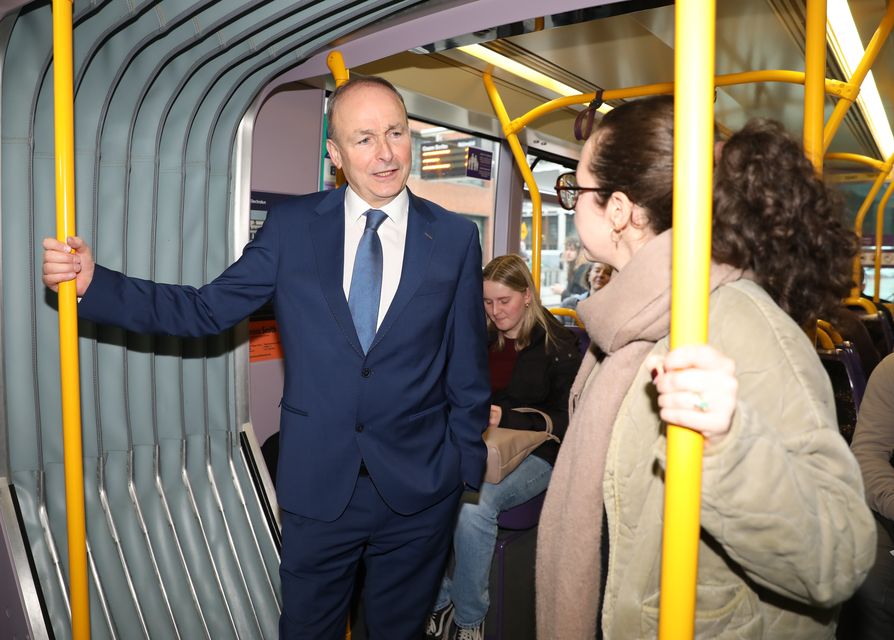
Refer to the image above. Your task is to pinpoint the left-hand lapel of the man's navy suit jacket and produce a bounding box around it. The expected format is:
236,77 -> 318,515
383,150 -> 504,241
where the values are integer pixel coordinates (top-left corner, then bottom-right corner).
310,187 -> 363,355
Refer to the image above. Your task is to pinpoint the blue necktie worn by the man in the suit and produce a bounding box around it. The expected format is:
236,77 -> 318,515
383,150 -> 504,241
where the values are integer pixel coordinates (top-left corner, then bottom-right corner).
348,209 -> 388,353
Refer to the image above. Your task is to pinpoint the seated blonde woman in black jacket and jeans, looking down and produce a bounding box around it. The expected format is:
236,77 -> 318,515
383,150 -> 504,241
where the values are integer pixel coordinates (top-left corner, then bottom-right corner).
426,255 -> 580,640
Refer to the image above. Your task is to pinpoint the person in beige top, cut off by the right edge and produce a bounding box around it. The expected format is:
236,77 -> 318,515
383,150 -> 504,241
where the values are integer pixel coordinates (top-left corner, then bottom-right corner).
838,355 -> 894,640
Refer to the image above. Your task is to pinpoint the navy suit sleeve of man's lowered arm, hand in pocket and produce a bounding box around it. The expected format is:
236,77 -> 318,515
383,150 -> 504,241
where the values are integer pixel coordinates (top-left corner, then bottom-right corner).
445,227 -> 490,489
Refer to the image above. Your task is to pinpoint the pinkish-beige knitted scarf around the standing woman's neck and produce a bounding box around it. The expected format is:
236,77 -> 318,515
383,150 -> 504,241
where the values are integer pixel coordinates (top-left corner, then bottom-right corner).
536,230 -> 742,640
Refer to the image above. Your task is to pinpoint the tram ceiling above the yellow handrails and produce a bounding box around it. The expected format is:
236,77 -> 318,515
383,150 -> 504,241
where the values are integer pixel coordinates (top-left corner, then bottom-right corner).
359,0 -> 894,158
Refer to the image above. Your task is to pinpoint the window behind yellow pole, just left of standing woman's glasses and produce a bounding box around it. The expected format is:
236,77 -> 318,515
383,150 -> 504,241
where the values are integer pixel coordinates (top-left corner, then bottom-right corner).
520,155 -> 577,307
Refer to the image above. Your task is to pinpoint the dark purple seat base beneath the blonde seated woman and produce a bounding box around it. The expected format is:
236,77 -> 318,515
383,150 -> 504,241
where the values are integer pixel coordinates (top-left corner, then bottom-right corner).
484,491 -> 546,640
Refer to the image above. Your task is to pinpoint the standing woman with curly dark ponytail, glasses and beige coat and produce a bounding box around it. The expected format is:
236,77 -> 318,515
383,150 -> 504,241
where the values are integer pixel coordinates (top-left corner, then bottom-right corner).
537,97 -> 875,640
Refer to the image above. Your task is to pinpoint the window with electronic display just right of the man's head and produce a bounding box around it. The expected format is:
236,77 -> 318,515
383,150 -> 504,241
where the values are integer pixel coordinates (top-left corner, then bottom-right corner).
407,118 -> 499,263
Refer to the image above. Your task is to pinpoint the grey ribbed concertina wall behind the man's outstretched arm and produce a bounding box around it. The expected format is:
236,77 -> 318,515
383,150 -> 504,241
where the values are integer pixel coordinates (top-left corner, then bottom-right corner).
0,0 -> 428,640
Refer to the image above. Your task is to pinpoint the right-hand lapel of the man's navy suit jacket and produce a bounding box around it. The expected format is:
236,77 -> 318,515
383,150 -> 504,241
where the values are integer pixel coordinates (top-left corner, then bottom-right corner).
372,193 -> 435,351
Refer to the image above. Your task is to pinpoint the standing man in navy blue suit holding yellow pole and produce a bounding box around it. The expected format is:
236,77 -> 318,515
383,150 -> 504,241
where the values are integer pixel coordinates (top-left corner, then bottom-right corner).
43,78 -> 490,640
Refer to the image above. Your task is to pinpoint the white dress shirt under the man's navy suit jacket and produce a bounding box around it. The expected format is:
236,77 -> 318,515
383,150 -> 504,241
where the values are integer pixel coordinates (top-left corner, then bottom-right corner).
342,186 -> 410,330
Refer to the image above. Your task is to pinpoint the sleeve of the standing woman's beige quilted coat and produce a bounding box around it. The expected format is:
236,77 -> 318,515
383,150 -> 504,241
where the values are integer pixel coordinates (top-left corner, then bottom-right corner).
702,284 -> 875,607
